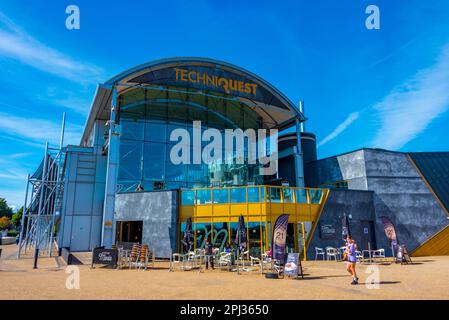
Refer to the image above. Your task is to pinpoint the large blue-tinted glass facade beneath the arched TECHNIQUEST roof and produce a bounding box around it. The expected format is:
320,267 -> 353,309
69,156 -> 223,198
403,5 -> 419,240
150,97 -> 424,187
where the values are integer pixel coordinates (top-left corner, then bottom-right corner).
117,86 -> 263,192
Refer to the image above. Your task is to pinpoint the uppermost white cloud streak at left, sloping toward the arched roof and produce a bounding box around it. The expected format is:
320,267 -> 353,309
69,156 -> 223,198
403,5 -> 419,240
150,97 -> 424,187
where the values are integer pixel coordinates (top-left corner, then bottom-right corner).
0,11 -> 101,83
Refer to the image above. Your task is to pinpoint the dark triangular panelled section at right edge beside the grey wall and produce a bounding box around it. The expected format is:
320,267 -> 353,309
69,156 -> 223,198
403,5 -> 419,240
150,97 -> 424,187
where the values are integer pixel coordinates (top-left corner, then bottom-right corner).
409,152 -> 449,212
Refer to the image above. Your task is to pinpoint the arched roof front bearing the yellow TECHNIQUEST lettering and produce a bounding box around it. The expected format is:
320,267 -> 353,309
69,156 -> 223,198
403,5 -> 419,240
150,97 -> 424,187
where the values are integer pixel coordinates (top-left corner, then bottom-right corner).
82,57 -> 305,142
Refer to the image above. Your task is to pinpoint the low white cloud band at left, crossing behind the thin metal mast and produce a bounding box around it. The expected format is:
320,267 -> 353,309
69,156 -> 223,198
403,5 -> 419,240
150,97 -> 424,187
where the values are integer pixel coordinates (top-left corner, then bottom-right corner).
0,112 -> 83,146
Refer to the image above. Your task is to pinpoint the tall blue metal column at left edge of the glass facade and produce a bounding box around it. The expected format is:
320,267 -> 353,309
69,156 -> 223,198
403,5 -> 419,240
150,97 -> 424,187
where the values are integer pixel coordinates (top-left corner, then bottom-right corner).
101,86 -> 120,248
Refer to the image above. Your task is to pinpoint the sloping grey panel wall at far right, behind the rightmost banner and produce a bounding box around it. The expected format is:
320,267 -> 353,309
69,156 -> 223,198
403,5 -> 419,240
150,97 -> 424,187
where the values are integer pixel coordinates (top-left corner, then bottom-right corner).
365,149 -> 449,255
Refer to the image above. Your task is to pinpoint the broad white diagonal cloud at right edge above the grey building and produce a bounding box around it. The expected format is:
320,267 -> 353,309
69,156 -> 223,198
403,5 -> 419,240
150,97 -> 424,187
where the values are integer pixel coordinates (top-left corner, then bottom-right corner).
372,45 -> 449,150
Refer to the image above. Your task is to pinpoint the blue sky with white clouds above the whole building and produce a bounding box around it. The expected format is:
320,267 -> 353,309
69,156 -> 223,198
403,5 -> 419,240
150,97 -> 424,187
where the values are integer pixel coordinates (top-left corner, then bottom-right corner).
0,0 -> 449,206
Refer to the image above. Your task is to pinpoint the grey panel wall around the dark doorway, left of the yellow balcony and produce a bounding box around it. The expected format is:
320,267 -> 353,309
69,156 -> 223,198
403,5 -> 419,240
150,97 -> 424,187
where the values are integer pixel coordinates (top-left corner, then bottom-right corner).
114,191 -> 178,258
